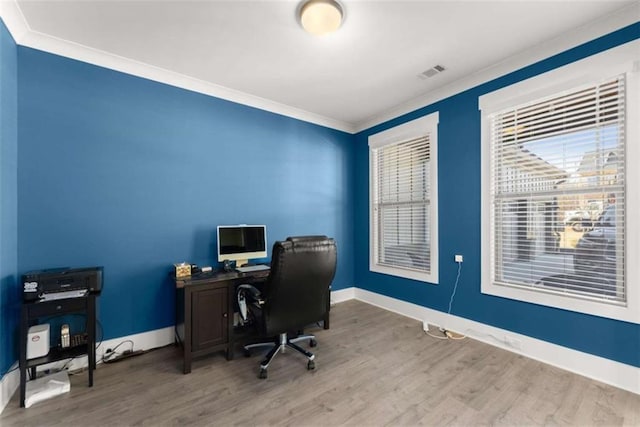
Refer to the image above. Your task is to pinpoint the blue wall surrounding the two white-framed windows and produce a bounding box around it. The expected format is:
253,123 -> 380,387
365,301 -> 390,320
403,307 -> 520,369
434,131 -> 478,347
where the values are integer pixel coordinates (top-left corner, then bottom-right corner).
354,23 -> 640,366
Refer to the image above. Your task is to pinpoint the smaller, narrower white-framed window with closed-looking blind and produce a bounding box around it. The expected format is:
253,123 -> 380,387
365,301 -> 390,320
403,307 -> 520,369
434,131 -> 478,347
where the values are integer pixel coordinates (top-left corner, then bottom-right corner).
369,113 -> 438,283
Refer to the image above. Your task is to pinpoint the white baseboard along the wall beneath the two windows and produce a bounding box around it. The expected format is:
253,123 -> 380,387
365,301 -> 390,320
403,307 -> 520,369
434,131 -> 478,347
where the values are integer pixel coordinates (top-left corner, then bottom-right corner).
350,288 -> 640,394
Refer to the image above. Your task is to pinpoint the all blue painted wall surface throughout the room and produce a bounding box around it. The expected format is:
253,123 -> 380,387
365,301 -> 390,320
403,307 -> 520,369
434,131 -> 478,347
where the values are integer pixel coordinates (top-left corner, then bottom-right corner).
0,17 -> 640,382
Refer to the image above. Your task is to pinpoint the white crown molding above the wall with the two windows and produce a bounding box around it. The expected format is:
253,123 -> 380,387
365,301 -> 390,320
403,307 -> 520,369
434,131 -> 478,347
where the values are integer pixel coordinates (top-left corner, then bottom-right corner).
354,2 -> 640,133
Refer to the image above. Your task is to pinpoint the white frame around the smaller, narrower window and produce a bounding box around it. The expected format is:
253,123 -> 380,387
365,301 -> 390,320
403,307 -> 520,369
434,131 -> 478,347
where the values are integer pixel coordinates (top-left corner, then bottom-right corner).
369,112 -> 439,284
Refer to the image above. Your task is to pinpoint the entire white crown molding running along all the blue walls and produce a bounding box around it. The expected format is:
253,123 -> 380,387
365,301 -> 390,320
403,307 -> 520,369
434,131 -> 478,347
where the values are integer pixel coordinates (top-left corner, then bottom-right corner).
0,0 -> 640,134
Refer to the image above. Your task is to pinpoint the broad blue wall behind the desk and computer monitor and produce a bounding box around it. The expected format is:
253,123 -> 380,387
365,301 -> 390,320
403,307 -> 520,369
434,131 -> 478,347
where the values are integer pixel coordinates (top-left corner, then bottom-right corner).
16,47 -> 354,350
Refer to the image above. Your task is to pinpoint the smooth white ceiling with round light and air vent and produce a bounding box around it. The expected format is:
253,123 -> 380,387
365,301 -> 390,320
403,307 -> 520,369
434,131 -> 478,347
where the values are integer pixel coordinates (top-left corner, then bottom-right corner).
6,0 -> 640,130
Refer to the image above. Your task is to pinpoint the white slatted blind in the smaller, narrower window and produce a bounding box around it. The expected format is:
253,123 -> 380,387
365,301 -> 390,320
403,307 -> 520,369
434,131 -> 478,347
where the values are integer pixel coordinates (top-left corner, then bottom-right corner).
372,135 -> 431,273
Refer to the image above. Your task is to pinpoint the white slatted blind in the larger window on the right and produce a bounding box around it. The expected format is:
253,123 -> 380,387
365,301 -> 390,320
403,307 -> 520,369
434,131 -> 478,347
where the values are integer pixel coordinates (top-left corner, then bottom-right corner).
488,75 -> 627,304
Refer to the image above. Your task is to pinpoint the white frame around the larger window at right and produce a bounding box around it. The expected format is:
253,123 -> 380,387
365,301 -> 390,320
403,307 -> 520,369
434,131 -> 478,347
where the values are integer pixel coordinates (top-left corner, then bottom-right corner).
479,40 -> 640,323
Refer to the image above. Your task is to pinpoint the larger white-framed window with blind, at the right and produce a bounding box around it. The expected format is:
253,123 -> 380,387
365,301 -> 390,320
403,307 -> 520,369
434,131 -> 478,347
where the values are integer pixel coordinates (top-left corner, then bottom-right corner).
480,43 -> 640,321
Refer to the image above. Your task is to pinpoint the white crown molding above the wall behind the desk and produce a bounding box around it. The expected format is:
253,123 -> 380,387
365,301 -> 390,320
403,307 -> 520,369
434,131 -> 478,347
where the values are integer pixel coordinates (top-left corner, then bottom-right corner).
0,0 -> 355,133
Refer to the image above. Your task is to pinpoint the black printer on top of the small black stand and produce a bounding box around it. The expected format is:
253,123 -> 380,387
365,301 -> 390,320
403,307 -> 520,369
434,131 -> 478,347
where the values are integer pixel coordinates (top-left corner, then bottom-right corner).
22,267 -> 103,302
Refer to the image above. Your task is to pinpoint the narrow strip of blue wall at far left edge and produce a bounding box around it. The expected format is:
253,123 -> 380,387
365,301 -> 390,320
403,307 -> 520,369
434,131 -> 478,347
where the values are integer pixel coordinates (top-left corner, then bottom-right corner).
0,20 -> 19,378
